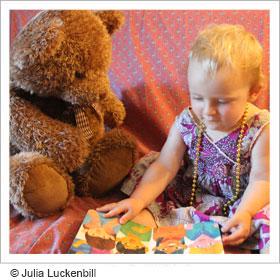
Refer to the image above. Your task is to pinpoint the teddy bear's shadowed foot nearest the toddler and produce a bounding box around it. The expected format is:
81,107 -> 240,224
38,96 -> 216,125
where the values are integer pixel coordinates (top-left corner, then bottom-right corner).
72,129 -> 137,197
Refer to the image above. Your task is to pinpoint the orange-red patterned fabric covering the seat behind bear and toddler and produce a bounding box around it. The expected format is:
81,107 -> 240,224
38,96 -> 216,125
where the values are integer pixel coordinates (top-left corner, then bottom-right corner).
10,10 -> 269,253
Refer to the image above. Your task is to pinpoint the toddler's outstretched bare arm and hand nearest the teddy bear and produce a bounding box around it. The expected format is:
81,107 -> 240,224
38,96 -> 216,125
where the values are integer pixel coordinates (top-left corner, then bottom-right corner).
97,123 -> 186,223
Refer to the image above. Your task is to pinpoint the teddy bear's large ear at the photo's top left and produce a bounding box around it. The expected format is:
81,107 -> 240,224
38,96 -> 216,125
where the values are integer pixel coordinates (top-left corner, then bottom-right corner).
11,11 -> 65,69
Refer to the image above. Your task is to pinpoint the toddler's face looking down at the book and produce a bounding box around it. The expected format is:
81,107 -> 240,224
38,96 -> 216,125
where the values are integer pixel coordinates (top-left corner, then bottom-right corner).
188,59 -> 250,132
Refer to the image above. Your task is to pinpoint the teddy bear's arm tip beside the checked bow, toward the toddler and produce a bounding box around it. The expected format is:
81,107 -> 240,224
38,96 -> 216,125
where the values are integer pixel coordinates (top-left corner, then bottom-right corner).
100,91 -> 125,128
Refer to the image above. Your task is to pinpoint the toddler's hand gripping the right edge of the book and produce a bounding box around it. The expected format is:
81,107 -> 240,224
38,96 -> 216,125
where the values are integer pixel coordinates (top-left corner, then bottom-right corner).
222,211 -> 252,246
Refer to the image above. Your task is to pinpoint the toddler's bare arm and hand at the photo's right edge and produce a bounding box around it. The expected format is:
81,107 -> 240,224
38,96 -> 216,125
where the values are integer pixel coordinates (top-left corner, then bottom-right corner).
222,126 -> 270,245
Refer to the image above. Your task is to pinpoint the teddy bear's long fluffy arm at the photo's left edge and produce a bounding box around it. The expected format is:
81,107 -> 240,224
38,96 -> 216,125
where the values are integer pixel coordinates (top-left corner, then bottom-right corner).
10,92 -> 90,172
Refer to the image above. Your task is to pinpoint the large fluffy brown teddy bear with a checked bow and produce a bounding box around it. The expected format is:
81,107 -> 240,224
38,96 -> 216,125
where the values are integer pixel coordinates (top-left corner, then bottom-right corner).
10,10 -> 137,217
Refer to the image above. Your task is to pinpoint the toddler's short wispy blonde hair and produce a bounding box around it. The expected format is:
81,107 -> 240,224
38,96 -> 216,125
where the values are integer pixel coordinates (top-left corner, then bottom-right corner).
189,24 -> 264,90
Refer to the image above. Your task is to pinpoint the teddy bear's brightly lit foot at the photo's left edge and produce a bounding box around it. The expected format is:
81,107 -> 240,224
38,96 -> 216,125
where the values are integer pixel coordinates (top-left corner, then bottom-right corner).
10,153 -> 73,217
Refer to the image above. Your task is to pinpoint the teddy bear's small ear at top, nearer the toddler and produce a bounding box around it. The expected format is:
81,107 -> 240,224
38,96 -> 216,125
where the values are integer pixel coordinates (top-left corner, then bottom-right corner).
96,11 -> 124,35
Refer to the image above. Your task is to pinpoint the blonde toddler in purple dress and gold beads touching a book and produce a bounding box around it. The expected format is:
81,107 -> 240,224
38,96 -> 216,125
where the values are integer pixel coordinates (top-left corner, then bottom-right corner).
97,24 -> 269,252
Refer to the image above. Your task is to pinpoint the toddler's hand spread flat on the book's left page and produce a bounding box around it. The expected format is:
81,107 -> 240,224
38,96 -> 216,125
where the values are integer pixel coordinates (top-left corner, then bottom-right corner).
96,198 -> 145,224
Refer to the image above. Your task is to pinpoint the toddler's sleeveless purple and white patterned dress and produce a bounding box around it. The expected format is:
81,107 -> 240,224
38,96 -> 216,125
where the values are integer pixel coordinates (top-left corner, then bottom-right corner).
122,108 -> 269,252
